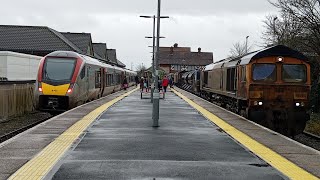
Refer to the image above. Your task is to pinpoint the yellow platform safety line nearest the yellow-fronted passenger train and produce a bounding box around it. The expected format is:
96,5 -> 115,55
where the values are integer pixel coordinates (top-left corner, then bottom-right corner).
9,88 -> 138,180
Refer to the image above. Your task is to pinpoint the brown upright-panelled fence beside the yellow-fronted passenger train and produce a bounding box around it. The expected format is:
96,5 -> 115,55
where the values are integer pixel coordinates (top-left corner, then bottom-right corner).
0,82 -> 35,122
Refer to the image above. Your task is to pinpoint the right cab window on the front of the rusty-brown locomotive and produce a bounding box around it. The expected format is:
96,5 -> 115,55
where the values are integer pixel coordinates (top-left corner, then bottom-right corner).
281,64 -> 307,82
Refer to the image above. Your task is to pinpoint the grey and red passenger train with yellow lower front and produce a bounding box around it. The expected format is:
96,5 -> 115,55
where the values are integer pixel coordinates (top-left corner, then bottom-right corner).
35,51 -> 136,113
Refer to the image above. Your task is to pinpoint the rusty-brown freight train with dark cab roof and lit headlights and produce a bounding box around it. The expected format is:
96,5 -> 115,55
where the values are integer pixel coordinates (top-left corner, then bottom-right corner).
174,45 -> 311,136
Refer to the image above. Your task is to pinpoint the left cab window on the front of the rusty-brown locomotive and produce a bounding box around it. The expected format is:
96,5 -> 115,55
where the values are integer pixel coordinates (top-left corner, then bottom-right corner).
252,64 -> 277,81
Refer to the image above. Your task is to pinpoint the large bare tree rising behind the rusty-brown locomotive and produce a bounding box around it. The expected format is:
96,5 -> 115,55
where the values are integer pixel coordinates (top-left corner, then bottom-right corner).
265,0 -> 320,56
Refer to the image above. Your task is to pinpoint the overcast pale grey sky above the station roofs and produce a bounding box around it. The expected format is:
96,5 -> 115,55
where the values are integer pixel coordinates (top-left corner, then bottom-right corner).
0,0 -> 277,69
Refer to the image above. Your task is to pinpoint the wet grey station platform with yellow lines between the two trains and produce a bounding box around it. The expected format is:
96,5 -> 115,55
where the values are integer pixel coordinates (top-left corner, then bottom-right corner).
0,89 -> 320,179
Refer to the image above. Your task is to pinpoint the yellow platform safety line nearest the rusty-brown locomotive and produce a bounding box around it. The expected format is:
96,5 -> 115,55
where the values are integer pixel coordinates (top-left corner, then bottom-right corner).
171,89 -> 318,180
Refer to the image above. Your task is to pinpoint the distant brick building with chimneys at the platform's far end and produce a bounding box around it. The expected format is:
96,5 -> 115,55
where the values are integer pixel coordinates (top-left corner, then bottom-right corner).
159,43 -> 213,74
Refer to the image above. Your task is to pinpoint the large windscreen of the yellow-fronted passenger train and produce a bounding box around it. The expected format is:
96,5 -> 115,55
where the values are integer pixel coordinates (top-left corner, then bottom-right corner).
43,57 -> 76,82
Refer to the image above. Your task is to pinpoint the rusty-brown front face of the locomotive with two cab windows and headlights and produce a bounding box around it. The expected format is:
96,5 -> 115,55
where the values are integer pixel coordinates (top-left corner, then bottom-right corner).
247,57 -> 310,135
